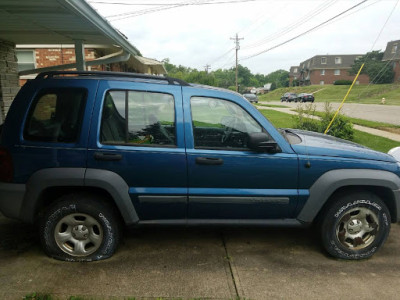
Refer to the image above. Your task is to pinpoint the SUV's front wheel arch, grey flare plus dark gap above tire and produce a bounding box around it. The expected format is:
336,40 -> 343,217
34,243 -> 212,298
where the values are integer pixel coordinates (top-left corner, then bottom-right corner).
297,169 -> 400,223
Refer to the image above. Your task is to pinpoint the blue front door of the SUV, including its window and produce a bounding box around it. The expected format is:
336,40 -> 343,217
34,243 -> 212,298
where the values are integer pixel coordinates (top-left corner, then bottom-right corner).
183,87 -> 298,220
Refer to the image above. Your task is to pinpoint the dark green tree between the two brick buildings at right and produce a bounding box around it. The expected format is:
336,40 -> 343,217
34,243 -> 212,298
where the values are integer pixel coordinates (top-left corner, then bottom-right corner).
350,51 -> 394,84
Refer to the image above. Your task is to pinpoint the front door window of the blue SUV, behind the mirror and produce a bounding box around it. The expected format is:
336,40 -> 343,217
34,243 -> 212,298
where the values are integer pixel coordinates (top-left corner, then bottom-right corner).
191,97 -> 263,150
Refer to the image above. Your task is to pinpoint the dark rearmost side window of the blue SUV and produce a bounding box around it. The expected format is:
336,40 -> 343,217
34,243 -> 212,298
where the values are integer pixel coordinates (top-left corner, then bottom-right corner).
24,88 -> 87,143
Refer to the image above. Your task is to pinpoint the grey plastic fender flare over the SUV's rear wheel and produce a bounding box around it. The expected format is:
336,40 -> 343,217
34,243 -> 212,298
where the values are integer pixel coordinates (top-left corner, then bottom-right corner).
19,168 -> 139,225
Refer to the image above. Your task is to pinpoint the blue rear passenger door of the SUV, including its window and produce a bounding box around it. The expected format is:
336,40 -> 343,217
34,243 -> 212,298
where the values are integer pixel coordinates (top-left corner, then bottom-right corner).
88,81 -> 187,220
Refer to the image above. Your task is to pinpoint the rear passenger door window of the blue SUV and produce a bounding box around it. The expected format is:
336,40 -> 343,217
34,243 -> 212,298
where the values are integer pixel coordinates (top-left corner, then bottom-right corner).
100,91 -> 176,146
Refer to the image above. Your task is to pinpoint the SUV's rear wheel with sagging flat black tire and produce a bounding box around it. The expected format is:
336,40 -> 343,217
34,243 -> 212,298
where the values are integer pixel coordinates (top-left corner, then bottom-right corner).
40,193 -> 120,261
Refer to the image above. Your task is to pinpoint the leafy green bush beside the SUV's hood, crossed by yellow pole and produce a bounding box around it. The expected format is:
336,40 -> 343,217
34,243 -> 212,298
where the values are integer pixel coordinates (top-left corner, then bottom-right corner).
293,102 -> 354,141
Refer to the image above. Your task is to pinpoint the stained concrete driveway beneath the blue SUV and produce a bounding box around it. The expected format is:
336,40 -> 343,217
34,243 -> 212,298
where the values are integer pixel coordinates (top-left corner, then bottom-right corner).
0,212 -> 400,299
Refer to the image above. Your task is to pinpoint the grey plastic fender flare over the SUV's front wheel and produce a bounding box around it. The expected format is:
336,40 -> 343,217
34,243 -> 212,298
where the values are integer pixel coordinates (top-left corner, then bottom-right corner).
297,169 -> 400,223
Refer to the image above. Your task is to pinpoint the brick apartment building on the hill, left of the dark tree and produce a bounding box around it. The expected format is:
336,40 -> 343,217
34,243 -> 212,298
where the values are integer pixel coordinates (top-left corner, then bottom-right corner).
289,54 -> 369,85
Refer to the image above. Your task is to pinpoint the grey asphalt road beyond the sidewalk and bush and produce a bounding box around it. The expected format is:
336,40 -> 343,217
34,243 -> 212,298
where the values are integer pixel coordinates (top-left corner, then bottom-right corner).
266,101 -> 400,126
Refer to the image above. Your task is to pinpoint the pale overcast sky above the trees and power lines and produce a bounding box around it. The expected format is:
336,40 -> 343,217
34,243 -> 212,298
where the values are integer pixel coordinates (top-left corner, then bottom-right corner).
88,0 -> 400,74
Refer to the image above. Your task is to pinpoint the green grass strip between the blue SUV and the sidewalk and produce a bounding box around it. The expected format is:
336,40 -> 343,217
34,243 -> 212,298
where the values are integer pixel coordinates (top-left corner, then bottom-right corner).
260,109 -> 400,153
